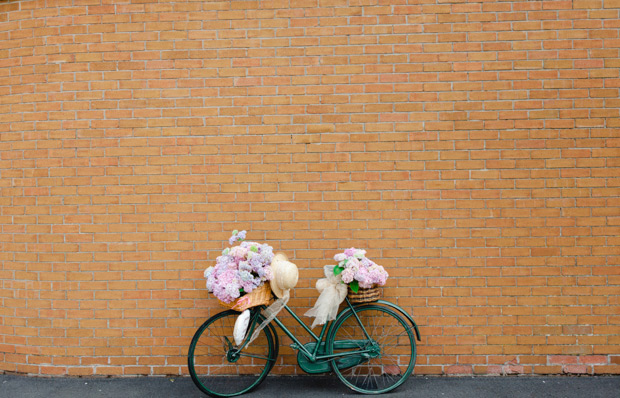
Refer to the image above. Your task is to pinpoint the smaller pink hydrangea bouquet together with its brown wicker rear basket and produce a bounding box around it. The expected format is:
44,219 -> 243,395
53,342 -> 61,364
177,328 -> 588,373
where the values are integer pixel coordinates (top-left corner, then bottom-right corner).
334,247 -> 389,303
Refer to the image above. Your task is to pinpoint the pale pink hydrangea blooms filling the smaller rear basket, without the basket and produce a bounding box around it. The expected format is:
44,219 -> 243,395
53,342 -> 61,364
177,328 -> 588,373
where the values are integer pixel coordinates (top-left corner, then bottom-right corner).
334,247 -> 388,289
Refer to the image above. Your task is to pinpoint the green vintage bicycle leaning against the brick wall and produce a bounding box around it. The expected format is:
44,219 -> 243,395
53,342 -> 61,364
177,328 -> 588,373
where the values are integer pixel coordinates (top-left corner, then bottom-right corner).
188,298 -> 420,397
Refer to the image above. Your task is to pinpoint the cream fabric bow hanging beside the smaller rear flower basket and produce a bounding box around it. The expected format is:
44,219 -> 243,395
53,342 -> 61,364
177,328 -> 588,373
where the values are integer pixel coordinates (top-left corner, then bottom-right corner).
304,265 -> 347,328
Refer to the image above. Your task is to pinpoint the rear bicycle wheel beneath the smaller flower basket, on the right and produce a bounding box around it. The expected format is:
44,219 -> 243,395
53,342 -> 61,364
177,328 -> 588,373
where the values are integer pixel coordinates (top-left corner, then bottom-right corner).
327,305 -> 416,394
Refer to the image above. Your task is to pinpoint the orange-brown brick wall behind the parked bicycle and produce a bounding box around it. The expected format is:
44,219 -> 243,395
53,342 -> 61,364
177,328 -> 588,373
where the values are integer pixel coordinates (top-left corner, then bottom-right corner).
0,0 -> 620,375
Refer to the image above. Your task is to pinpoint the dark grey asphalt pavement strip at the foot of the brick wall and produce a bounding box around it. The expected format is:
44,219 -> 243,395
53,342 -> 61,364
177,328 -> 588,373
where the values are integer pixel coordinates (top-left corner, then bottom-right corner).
0,374 -> 620,398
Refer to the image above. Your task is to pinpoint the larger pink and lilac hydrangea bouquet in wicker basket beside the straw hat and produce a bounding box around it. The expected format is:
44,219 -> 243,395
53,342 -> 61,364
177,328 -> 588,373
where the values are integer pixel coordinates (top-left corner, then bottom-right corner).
204,230 -> 274,311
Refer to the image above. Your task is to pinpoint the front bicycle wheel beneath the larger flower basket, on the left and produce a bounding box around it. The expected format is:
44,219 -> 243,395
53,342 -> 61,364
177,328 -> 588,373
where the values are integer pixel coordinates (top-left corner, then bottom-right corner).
187,310 -> 277,397
